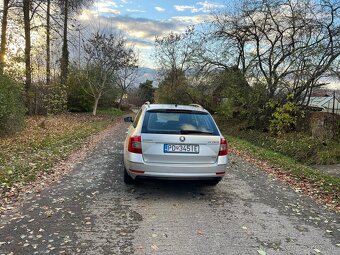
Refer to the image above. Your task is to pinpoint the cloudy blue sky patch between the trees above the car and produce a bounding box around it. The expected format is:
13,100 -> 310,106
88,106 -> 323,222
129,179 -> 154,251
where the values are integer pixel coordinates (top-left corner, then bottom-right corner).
78,0 -> 231,68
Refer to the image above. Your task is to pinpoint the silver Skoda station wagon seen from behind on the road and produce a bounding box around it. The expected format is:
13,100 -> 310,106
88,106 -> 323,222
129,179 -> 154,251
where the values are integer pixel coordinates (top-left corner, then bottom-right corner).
124,102 -> 228,185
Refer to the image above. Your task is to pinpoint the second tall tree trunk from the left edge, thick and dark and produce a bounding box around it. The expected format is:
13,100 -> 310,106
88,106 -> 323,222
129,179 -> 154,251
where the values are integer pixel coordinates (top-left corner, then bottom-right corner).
23,0 -> 32,114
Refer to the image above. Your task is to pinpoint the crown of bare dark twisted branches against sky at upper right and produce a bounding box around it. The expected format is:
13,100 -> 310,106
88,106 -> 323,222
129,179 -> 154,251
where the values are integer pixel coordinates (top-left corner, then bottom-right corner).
209,0 -> 340,101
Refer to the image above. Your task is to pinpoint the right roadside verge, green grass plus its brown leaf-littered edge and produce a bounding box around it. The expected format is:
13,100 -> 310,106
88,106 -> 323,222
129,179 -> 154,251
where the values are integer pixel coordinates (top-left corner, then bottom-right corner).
222,125 -> 340,207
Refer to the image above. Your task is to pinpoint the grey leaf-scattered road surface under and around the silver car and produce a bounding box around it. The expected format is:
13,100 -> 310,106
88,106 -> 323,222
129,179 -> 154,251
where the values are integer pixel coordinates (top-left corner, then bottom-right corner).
0,122 -> 340,255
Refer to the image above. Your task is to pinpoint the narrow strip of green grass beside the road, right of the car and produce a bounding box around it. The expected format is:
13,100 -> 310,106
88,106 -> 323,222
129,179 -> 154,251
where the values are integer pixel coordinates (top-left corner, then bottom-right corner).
226,135 -> 340,197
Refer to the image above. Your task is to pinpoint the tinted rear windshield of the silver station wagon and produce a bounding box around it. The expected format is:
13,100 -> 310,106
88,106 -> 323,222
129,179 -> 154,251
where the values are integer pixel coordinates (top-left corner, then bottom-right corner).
142,110 -> 219,135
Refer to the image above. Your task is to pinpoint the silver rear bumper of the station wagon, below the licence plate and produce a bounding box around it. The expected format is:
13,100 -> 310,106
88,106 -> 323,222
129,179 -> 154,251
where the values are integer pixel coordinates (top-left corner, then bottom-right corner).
125,153 -> 227,180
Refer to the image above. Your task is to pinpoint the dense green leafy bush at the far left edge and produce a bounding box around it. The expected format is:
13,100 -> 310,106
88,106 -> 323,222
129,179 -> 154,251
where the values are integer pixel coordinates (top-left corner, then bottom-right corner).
0,75 -> 26,135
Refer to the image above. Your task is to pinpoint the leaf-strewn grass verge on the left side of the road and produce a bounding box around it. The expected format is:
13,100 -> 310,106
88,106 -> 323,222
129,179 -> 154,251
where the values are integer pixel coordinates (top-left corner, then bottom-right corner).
0,114 -> 110,190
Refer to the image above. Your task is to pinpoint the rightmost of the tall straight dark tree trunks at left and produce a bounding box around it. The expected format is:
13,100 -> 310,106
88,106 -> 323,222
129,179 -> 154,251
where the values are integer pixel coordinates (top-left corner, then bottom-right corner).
60,0 -> 69,84
